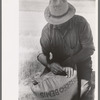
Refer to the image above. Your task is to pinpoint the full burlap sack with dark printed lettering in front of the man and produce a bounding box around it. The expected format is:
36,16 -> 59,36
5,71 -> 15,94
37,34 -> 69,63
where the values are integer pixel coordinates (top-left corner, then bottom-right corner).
31,71 -> 78,100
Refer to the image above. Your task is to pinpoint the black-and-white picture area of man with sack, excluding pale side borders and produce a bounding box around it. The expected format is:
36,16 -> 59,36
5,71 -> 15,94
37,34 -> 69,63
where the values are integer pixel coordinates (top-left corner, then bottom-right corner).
18,0 -> 98,100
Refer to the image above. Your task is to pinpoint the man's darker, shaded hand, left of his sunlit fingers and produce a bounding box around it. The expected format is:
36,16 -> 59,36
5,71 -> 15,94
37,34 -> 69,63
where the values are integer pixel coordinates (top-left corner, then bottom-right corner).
48,63 -> 64,75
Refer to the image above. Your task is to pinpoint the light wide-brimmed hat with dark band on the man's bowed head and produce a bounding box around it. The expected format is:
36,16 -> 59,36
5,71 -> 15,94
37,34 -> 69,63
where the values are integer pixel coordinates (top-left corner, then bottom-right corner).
44,0 -> 76,25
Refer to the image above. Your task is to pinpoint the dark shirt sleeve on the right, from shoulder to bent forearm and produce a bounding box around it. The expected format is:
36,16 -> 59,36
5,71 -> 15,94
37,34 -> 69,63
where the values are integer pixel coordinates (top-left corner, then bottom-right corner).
72,20 -> 95,63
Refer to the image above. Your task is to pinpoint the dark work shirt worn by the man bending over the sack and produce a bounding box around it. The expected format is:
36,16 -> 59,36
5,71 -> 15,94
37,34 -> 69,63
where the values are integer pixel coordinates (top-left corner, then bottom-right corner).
40,15 -> 94,67
